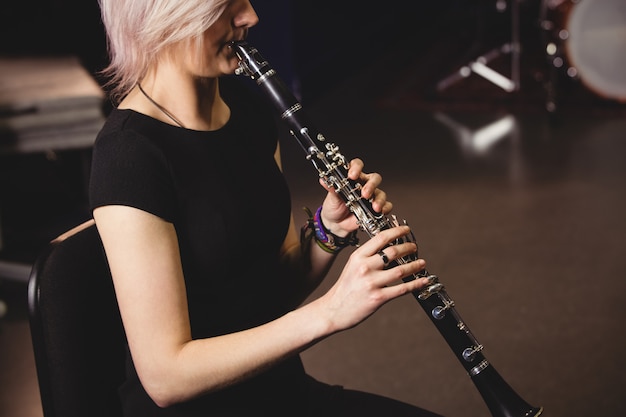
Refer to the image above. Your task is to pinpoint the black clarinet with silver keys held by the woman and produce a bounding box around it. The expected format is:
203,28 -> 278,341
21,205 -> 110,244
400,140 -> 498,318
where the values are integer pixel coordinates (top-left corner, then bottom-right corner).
230,41 -> 543,417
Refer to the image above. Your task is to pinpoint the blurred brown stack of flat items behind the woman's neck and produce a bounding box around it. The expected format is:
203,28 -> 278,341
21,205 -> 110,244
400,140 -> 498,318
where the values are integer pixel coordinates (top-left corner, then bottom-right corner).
0,56 -> 104,154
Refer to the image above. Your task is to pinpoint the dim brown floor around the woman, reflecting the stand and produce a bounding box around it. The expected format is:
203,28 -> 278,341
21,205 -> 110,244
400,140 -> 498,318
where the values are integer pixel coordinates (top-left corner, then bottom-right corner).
0,9 -> 626,417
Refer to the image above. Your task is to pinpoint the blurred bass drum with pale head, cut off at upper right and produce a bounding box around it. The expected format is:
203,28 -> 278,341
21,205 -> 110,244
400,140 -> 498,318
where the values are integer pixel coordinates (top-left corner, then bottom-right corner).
540,0 -> 626,102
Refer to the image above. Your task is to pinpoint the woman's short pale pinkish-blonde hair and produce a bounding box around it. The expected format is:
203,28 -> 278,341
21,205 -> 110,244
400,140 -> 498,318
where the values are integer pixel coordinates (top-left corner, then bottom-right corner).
98,0 -> 229,102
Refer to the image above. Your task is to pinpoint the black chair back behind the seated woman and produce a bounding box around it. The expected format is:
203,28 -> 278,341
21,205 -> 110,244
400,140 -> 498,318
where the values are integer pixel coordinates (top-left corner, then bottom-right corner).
28,219 -> 126,417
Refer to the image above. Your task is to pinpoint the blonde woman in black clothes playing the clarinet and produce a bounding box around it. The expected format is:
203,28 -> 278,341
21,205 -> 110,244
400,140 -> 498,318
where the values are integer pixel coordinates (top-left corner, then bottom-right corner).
90,0 -> 442,417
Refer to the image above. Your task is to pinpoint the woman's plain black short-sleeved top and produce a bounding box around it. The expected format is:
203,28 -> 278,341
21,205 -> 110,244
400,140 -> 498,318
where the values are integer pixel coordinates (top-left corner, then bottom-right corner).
90,77 -> 304,417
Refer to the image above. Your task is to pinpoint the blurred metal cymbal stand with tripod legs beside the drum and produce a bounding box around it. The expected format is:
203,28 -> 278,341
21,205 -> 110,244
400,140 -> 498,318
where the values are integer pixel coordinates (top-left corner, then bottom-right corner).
437,0 -> 520,93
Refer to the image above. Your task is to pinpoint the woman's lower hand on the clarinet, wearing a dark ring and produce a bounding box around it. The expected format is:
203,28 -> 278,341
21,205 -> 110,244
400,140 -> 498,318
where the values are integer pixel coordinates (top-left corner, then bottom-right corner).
319,226 -> 429,332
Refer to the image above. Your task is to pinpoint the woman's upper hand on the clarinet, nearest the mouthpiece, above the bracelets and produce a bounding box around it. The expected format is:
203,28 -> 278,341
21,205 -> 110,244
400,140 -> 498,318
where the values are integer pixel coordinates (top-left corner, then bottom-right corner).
320,158 -> 393,236
